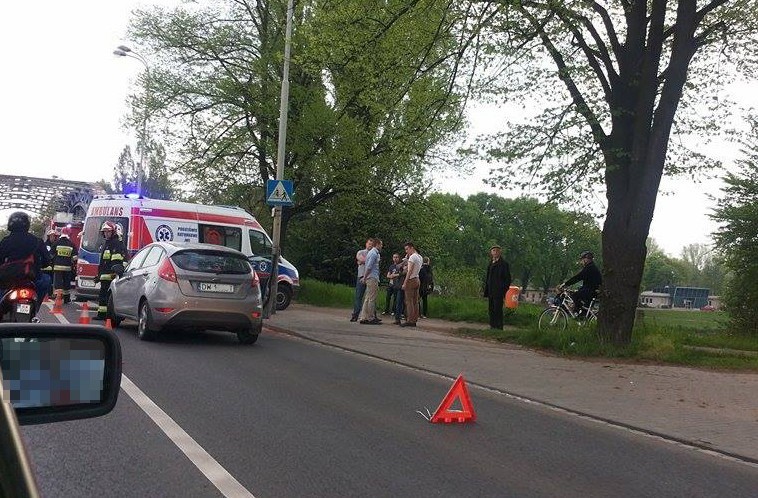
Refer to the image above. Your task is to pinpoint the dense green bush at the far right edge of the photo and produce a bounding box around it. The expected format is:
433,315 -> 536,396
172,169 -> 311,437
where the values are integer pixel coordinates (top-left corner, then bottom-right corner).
713,121 -> 758,336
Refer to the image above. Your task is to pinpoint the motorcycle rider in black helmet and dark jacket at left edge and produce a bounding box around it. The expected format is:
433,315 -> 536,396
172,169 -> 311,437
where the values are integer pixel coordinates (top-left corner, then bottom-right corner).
0,211 -> 51,316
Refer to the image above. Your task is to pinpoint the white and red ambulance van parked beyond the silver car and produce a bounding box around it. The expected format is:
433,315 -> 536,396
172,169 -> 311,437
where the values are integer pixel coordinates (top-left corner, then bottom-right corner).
76,194 -> 300,310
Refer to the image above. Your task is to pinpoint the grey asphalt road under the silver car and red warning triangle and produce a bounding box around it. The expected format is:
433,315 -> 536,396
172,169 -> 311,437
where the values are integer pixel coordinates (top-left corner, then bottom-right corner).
17,305 -> 758,498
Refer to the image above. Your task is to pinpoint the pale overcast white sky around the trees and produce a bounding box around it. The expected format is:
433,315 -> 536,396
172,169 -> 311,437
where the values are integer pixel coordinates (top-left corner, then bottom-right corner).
0,0 -> 756,256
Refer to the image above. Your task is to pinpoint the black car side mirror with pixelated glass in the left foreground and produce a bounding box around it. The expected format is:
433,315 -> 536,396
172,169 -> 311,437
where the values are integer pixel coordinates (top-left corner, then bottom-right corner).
0,323 -> 121,425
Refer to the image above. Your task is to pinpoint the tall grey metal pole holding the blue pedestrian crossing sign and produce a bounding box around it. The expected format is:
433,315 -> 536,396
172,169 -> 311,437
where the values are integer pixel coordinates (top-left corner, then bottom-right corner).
263,0 -> 294,318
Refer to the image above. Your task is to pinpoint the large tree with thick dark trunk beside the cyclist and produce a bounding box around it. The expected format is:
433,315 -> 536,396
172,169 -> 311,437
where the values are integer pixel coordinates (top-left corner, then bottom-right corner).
472,0 -> 756,344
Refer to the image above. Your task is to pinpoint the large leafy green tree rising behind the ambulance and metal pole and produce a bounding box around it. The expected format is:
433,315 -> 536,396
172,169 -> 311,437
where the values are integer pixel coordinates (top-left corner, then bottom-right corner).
131,0 -> 473,245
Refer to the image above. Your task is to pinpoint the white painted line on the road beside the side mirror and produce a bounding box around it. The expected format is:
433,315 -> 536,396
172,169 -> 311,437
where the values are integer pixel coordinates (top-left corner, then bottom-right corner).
46,303 -> 255,498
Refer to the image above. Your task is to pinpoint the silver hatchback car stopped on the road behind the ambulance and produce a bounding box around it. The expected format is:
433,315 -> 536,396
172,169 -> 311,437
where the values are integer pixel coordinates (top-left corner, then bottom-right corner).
108,242 -> 263,344
